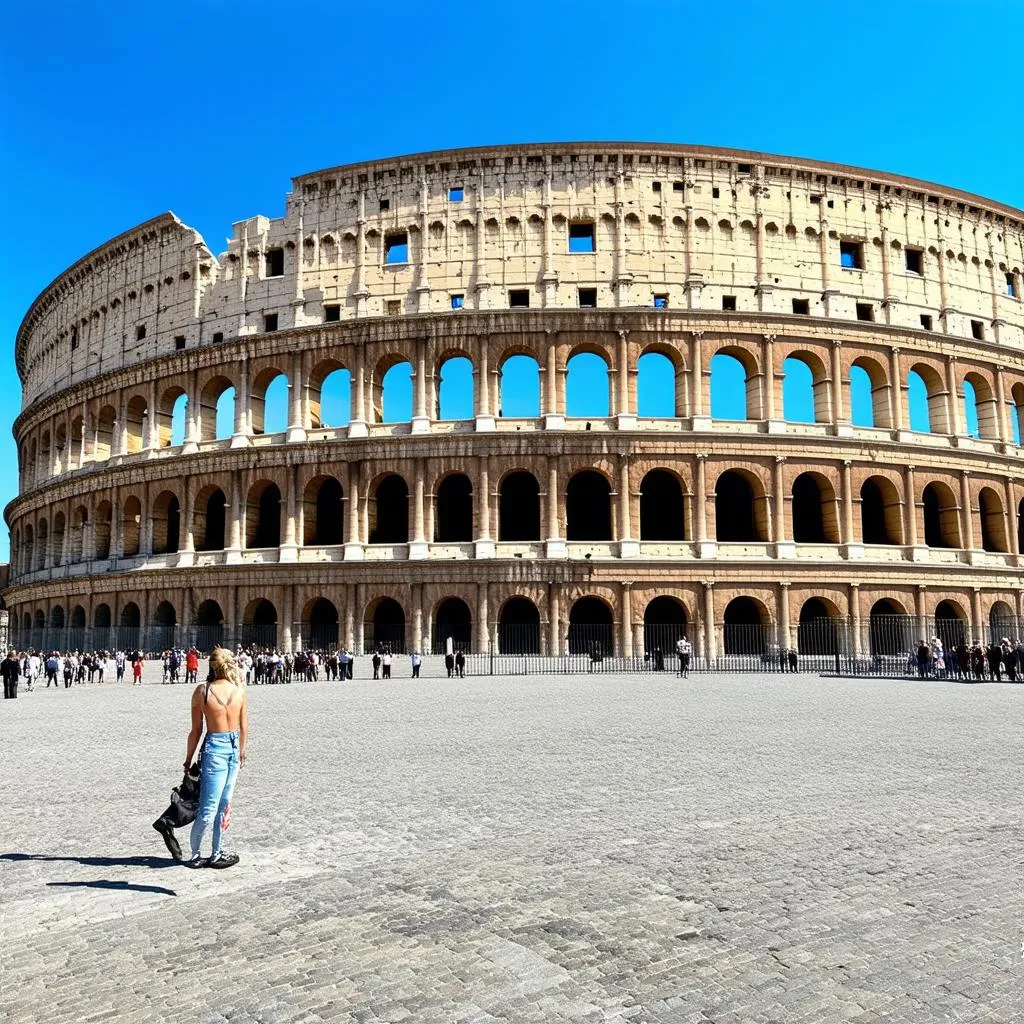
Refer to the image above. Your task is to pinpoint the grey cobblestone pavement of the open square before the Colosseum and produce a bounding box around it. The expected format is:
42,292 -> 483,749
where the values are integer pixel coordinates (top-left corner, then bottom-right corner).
0,676 -> 1024,1024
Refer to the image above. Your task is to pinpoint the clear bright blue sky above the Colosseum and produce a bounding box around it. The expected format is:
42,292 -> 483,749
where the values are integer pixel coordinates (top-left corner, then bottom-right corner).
0,0 -> 1024,560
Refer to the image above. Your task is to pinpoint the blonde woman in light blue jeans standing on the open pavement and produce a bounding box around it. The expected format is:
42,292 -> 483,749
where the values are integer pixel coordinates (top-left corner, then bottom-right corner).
184,647 -> 249,867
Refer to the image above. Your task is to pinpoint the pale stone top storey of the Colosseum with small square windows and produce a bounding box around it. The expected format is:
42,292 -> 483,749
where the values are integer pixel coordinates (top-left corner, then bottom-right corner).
16,143 -> 1024,406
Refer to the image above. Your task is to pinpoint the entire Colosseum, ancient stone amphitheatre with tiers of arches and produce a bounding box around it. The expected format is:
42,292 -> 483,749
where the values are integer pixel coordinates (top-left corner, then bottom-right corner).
6,143 -> 1024,658
